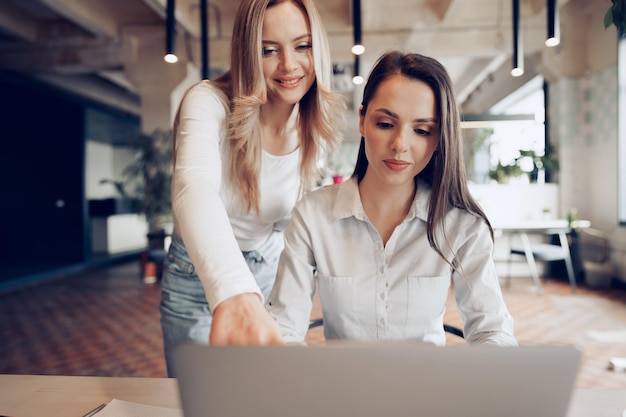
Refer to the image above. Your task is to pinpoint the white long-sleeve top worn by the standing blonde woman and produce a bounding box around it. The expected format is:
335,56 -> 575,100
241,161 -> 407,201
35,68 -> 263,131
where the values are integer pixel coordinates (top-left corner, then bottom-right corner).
172,81 -> 300,310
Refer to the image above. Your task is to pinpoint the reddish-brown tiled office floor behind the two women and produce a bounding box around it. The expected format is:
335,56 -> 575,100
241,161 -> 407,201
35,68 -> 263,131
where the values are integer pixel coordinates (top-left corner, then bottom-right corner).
0,262 -> 626,388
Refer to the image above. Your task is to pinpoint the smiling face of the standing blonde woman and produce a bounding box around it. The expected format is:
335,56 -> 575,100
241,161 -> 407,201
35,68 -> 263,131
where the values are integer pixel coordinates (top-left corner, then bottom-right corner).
262,1 -> 315,105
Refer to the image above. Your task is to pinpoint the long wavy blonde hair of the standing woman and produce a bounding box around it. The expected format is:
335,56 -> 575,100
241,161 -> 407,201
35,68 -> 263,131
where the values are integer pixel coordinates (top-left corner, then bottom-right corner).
214,0 -> 345,213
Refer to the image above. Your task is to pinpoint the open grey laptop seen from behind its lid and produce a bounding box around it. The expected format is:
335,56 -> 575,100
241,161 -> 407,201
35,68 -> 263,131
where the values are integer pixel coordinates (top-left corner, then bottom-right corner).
175,342 -> 581,417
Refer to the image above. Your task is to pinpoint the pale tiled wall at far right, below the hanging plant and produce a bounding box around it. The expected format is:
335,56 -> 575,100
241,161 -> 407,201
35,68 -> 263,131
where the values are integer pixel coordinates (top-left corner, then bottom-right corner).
549,65 -> 626,282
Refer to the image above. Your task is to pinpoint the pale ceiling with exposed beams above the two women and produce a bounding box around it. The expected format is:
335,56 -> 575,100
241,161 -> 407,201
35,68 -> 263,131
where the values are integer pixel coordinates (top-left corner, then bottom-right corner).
0,0 -> 569,111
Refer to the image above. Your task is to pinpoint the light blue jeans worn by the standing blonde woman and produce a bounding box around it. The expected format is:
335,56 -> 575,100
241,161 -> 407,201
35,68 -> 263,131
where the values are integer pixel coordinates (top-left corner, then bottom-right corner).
161,232 -> 283,378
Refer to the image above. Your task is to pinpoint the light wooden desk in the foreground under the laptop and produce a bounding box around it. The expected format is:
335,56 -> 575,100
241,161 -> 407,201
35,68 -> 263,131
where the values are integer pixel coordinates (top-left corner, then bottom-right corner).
0,375 -> 626,417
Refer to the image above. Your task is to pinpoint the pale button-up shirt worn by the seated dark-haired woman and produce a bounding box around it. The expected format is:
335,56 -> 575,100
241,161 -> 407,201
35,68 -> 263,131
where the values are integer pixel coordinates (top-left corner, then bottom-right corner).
267,178 -> 517,346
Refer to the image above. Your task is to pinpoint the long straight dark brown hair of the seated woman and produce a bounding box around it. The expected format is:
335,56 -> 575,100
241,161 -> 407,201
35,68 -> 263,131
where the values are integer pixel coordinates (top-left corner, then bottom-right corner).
352,51 -> 493,265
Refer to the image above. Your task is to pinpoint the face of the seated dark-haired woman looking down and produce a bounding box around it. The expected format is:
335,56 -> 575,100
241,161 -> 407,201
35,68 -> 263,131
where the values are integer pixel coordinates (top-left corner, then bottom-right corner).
359,75 -> 439,187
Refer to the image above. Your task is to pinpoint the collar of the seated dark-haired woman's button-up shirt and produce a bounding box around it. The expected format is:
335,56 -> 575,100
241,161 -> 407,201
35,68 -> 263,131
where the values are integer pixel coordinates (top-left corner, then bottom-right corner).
333,176 -> 430,221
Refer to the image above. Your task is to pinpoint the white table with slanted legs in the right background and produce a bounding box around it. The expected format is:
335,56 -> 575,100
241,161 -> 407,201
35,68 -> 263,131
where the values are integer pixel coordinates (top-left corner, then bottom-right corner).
492,220 -> 591,294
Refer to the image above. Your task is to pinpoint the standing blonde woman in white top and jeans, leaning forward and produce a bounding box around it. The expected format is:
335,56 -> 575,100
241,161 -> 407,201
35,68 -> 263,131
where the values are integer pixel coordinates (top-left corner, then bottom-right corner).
161,0 -> 343,377
